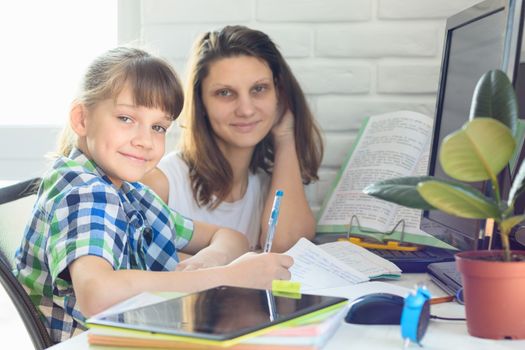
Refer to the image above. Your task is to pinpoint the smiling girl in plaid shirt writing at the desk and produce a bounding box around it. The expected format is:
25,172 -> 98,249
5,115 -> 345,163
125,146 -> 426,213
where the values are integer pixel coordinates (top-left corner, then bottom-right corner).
16,48 -> 292,342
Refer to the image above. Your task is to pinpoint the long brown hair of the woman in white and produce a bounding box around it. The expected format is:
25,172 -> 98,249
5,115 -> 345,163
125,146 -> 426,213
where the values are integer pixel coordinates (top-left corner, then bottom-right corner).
180,26 -> 323,208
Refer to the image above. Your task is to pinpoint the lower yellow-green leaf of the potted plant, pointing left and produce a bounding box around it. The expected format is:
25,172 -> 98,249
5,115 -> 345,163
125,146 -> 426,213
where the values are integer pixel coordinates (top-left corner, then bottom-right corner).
417,180 -> 501,219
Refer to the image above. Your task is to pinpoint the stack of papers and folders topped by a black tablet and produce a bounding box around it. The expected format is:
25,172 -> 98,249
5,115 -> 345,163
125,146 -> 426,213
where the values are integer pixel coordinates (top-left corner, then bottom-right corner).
87,287 -> 348,350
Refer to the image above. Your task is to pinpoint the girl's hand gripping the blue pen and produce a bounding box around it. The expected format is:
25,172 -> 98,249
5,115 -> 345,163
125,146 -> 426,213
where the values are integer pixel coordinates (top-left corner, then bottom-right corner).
223,252 -> 293,289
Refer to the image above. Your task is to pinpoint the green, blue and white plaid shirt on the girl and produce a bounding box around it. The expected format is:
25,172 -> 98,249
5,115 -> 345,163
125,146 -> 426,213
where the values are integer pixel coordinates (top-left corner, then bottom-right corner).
16,149 -> 193,342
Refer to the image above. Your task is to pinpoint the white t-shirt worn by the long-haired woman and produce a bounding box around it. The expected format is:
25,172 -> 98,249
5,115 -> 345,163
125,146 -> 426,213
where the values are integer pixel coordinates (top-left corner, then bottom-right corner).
158,152 -> 270,250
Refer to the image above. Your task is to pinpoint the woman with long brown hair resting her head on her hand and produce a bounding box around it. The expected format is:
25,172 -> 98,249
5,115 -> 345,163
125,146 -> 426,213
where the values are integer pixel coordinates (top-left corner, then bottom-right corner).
143,26 -> 323,251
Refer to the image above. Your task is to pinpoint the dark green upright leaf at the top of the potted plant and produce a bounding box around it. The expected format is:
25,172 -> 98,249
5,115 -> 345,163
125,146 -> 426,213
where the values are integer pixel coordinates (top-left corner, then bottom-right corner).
470,70 -> 519,135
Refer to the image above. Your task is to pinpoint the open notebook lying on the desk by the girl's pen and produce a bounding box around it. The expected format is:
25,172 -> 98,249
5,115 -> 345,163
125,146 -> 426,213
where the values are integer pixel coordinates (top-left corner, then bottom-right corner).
285,238 -> 401,293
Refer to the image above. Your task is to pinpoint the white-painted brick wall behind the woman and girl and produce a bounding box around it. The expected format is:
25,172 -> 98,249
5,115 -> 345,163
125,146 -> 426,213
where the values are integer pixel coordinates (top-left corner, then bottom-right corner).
133,0 -> 480,212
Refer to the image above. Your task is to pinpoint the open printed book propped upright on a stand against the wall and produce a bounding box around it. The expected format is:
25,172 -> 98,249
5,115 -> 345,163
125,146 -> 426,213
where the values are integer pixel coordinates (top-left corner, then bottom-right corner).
317,111 -> 451,249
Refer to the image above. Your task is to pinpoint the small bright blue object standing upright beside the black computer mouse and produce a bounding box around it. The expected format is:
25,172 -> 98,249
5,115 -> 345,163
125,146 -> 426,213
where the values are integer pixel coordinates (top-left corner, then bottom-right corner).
401,285 -> 431,349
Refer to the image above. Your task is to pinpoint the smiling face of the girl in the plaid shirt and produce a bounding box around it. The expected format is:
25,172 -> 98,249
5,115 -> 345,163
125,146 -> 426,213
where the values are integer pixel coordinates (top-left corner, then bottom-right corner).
72,86 -> 171,187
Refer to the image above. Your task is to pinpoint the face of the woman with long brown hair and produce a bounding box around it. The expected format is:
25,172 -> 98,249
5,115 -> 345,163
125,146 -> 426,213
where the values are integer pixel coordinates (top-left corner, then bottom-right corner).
202,56 -> 277,152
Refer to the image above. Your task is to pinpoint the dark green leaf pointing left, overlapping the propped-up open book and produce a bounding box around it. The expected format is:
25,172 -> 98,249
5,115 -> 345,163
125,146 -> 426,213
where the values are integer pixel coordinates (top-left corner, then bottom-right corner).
363,176 -> 434,210
